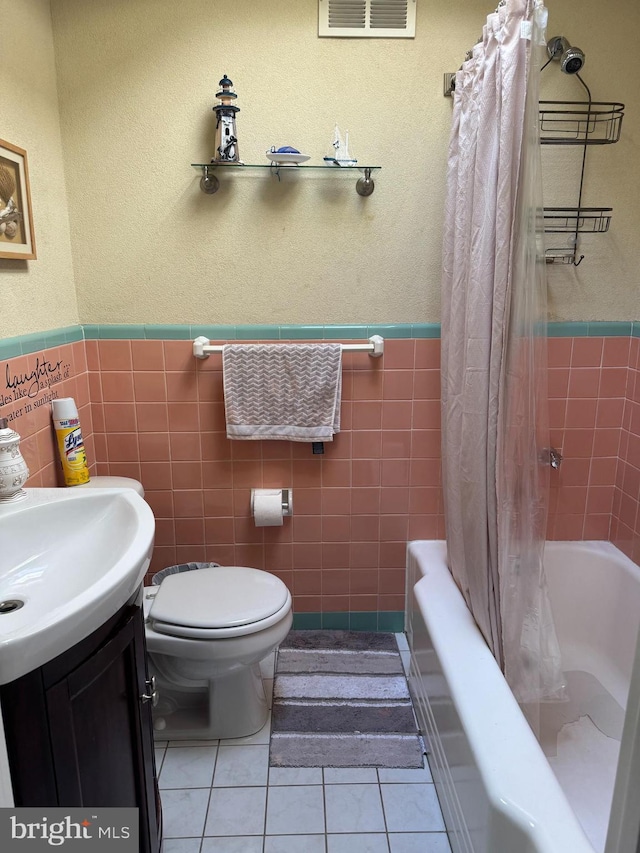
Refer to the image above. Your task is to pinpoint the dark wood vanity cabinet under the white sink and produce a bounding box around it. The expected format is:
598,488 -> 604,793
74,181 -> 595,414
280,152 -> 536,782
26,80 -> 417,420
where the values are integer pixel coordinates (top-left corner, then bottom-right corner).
0,601 -> 162,853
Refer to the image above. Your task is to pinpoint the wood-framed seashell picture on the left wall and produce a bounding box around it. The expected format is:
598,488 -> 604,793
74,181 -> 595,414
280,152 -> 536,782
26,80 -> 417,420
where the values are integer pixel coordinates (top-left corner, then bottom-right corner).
0,139 -> 36,260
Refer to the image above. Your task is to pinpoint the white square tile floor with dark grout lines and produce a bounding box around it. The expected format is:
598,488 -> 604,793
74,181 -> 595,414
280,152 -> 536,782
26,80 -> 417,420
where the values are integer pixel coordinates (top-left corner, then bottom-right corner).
156,636 -> 450,853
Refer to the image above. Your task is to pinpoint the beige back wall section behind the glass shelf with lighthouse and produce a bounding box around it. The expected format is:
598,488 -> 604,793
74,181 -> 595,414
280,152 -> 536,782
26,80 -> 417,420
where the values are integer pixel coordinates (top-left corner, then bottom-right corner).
52,0 -> 486,323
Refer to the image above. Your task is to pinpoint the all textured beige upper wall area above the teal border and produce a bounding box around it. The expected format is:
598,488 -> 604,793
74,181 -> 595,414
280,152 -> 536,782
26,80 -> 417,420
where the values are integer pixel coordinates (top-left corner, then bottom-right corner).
0,0 -> 640,335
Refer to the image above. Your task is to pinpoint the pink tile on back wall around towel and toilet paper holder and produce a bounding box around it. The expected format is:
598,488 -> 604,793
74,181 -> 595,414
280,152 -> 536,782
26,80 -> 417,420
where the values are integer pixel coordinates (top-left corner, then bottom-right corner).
86,340 -> 443,612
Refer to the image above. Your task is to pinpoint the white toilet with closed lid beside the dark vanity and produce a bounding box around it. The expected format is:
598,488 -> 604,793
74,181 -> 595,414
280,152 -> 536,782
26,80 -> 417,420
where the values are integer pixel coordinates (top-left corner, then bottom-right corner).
75,477 -> 293,740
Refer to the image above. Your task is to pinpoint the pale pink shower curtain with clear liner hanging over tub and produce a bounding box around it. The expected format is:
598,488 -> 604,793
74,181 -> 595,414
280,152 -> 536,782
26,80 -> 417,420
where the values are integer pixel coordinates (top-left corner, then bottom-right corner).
442,0 -> 563,704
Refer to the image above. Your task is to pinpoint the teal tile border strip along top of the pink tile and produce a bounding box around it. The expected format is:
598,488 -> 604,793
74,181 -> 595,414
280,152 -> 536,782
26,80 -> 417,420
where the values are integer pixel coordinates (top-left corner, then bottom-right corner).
0,320 -> 640,359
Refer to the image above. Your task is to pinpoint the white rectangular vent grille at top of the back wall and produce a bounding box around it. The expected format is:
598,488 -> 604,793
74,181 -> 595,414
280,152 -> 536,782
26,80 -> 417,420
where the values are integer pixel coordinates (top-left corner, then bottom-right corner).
318,0 -> 417,38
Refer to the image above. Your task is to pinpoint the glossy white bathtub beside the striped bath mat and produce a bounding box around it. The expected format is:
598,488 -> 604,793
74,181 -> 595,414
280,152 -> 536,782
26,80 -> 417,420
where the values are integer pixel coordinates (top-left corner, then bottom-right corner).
406,541 -> 640,853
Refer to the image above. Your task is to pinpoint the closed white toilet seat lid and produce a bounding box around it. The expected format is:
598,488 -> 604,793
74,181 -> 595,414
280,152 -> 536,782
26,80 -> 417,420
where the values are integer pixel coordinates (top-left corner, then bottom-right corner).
149,566 -> 289,628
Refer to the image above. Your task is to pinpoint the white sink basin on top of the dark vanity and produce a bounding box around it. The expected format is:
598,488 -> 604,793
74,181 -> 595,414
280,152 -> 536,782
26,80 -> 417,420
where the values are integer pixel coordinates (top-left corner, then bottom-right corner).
0,488 -> 155,684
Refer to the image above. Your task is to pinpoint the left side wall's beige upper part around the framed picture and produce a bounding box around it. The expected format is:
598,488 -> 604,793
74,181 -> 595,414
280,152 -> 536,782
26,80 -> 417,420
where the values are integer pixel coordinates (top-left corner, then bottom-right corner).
0,0 -> 78,338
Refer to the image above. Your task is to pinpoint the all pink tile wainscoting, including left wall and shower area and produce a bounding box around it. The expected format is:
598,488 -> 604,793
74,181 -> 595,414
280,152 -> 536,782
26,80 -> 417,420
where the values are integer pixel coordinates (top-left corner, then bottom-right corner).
0,324 -> 640,630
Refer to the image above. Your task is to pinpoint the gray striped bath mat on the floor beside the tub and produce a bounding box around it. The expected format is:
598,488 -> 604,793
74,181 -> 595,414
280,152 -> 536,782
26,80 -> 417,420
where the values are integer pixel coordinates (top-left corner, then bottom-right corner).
269,631 -> 423,767
